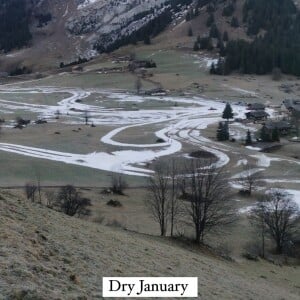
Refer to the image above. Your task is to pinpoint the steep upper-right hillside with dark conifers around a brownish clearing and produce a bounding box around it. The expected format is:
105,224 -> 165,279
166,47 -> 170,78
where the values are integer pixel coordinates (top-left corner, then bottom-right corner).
187,0 -> 300,76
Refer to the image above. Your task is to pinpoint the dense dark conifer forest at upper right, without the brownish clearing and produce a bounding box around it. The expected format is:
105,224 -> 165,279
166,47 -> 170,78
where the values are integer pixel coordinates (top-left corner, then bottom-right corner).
204,0 -> 300,76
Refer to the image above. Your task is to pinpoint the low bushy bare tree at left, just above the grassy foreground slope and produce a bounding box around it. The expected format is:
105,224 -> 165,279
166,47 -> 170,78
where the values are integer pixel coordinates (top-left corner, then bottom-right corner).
56,185 -> 91,216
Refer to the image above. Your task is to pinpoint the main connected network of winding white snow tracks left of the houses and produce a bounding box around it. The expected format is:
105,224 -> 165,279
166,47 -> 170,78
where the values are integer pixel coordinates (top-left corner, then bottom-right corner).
0,86 -> 245,176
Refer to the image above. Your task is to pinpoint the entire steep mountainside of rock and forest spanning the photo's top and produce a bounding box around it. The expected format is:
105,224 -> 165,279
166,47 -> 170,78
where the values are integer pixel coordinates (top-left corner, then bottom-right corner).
0,0 -> 300,76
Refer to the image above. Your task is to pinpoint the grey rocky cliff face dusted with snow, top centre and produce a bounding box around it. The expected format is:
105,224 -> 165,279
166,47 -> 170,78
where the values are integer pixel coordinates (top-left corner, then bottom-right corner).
66,0 -> 192,51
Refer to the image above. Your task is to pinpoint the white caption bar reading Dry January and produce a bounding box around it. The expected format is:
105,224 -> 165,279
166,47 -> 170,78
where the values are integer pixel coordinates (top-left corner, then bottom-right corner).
102,277 -> 198,298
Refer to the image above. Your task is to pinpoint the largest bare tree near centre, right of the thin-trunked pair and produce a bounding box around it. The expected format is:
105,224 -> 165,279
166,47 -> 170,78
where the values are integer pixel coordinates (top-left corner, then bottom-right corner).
186,159 -> 235,243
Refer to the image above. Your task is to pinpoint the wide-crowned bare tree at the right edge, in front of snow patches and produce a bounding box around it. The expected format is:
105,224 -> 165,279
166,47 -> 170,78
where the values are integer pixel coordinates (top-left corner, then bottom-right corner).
251,189 -> 300,254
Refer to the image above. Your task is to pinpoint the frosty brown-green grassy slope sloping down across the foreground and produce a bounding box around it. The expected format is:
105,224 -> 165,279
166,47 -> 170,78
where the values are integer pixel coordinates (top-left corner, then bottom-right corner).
0,191 -> 299,299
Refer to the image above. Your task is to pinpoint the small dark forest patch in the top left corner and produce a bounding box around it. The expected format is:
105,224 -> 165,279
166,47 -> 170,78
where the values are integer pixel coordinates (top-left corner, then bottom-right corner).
0,0 -> 32,52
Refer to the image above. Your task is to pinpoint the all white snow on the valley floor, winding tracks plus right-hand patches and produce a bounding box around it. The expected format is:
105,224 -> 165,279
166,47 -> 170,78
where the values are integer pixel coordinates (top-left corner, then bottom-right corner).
0,85 -> 300,206
